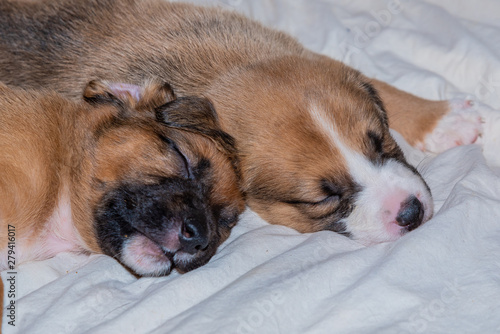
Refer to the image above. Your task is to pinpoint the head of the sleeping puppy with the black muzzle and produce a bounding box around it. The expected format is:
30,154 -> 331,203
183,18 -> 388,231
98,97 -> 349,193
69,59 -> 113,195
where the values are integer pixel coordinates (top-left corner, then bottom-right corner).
84,81 -> 244,275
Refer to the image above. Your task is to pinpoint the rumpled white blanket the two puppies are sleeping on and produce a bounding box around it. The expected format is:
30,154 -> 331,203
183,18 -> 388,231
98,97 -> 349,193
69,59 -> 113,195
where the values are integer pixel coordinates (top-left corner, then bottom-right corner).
2,0 -> 500,334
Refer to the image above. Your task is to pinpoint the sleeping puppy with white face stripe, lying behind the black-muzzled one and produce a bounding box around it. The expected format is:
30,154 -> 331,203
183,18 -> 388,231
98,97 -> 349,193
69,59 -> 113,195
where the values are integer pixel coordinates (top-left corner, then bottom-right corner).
0,0 -> 480,244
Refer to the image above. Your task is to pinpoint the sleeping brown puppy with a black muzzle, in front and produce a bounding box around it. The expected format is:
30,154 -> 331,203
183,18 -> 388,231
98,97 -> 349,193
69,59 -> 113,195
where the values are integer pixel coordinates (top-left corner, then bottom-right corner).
0,81 -> 244,276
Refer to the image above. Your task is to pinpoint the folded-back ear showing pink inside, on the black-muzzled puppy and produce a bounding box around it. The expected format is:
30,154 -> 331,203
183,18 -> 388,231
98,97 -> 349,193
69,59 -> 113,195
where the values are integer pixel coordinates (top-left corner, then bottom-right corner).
83,80 -> 175,112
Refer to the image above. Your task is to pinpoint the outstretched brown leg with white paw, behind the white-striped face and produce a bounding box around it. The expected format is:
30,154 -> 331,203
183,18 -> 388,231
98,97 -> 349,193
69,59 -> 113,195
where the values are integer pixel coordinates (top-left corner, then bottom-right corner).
371,80 -> 482,153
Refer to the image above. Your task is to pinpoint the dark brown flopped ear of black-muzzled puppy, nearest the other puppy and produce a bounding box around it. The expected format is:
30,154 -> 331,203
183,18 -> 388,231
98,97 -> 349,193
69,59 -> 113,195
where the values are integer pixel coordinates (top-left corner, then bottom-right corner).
156,96 -> 236,157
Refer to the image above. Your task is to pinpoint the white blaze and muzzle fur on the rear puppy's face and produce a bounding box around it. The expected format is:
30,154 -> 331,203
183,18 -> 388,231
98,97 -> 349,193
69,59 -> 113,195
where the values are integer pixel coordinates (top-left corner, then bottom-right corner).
310,107 -> 433,245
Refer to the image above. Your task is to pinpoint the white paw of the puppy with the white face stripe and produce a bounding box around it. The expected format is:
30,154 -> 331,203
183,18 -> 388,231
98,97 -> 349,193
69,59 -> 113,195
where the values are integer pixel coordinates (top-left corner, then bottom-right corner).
418,99 -> 484,153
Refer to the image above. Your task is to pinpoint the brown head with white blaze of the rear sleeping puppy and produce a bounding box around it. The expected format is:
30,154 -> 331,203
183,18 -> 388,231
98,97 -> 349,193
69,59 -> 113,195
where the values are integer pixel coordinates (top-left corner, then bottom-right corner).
213,57 -> 433,244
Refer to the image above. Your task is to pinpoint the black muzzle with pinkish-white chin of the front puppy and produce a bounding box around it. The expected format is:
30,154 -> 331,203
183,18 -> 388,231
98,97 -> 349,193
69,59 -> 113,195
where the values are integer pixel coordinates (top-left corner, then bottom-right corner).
95,178 -> 229,276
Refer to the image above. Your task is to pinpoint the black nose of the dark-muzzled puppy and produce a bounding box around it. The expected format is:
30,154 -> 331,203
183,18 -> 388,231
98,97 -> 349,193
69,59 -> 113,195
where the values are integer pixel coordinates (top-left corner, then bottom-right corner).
179,218 -> 208,254
